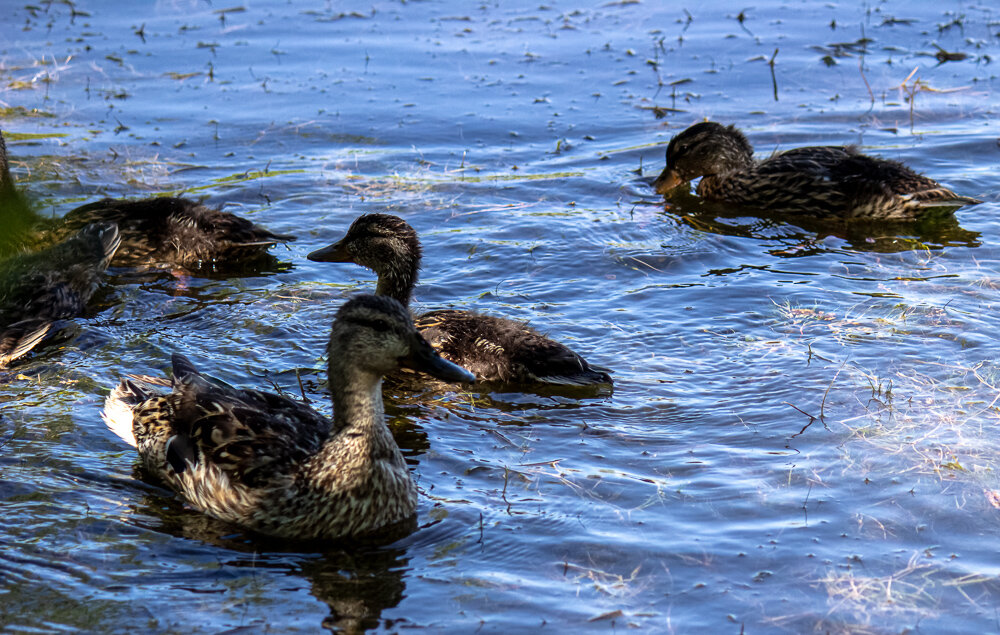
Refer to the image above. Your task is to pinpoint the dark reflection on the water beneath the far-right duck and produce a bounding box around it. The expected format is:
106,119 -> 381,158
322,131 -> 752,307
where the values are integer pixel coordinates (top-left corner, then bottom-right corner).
657,190 -> 981,258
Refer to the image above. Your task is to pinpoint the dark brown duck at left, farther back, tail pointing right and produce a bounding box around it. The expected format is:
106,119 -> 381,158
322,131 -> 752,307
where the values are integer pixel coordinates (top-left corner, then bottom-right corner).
0,131 -> 295,271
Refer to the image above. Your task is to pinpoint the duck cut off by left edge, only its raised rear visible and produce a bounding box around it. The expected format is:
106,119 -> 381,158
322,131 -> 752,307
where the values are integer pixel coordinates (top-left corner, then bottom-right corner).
0,222 -> 121,368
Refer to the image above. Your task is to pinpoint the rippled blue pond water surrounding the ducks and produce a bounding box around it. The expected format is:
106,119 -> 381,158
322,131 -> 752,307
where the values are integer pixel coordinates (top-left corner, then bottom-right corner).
0,0 -> 1000,633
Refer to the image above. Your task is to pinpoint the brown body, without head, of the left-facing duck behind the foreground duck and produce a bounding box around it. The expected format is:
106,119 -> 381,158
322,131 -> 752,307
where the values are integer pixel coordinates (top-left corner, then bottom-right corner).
415,309 -> 612,386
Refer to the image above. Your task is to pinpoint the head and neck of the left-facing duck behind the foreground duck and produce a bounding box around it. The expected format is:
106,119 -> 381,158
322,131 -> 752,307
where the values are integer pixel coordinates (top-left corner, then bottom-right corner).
307,214 -> 421,306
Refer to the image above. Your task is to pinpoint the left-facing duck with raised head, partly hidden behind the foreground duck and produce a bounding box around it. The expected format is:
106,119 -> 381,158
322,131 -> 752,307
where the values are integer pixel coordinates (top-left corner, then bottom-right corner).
307,213 -> 613,386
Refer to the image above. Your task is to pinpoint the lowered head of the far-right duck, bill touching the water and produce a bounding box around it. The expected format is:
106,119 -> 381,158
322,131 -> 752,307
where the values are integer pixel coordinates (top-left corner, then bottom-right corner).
653,121 -> 753,194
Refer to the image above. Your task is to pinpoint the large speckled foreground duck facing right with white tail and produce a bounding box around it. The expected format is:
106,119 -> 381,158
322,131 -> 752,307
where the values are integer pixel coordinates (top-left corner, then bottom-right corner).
103,294 -> 475,540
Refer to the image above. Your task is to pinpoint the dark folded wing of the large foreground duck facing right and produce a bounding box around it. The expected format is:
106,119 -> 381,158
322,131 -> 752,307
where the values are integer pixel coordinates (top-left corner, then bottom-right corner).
129,354 -> 331,487
